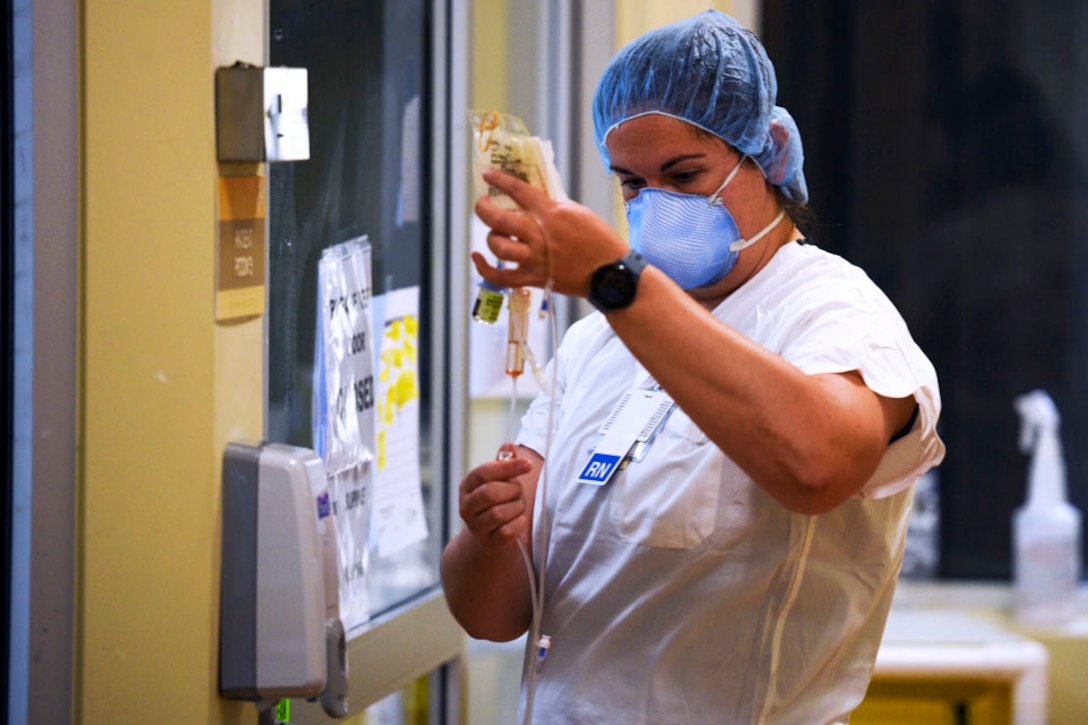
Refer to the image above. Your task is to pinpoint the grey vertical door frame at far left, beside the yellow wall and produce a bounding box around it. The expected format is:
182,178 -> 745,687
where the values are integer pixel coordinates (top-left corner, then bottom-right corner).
4,0 -> 79,723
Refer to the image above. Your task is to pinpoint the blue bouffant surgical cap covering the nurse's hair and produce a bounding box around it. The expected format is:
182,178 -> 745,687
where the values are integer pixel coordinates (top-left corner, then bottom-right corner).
593,10 -> 808,204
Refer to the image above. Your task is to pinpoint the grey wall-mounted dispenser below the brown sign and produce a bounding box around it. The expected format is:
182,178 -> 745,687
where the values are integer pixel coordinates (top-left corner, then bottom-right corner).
220,443 -> 347,717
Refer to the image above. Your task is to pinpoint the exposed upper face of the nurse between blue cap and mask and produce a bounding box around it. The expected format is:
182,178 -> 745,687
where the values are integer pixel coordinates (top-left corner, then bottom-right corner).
605,113 -> 741,206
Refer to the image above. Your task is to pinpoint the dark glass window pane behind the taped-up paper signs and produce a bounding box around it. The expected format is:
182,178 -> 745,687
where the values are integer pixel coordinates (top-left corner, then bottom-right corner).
268,0 -> 444,615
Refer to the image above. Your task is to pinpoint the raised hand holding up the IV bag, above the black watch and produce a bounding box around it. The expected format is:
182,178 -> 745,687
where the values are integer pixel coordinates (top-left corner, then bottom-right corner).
472,170 -> 628,297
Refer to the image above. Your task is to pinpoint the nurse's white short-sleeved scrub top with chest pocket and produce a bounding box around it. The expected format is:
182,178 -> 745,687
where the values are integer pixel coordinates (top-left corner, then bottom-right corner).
518,243 -> 944,725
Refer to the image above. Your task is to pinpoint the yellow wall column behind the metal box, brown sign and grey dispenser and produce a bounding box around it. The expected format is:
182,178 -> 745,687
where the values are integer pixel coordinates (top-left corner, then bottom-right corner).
74,0 -> 264,724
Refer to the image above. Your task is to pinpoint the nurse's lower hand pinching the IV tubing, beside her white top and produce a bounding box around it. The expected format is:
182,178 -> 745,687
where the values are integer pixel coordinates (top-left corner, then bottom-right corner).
459,443 -> 532,549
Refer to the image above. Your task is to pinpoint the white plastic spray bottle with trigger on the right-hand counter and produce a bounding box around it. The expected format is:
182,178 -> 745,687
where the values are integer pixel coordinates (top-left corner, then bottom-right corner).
1013,390 -> 1080,625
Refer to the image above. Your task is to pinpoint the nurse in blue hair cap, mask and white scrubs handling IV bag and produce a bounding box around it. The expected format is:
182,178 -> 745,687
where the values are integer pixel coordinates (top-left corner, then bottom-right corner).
442,11 -> 944,724
